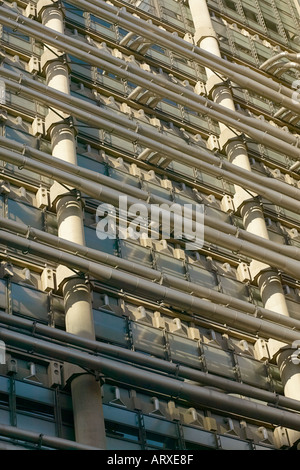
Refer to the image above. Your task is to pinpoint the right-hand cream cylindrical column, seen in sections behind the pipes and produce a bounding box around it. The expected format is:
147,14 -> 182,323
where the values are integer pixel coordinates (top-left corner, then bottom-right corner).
189,0 -> 300,443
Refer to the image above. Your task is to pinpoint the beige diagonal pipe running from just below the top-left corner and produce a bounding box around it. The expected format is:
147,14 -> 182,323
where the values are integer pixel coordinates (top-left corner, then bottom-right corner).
3,10 -> 298,155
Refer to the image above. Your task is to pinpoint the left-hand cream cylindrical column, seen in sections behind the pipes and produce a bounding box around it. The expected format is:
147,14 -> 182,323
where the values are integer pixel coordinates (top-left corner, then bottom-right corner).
37,0 -> 106,449
